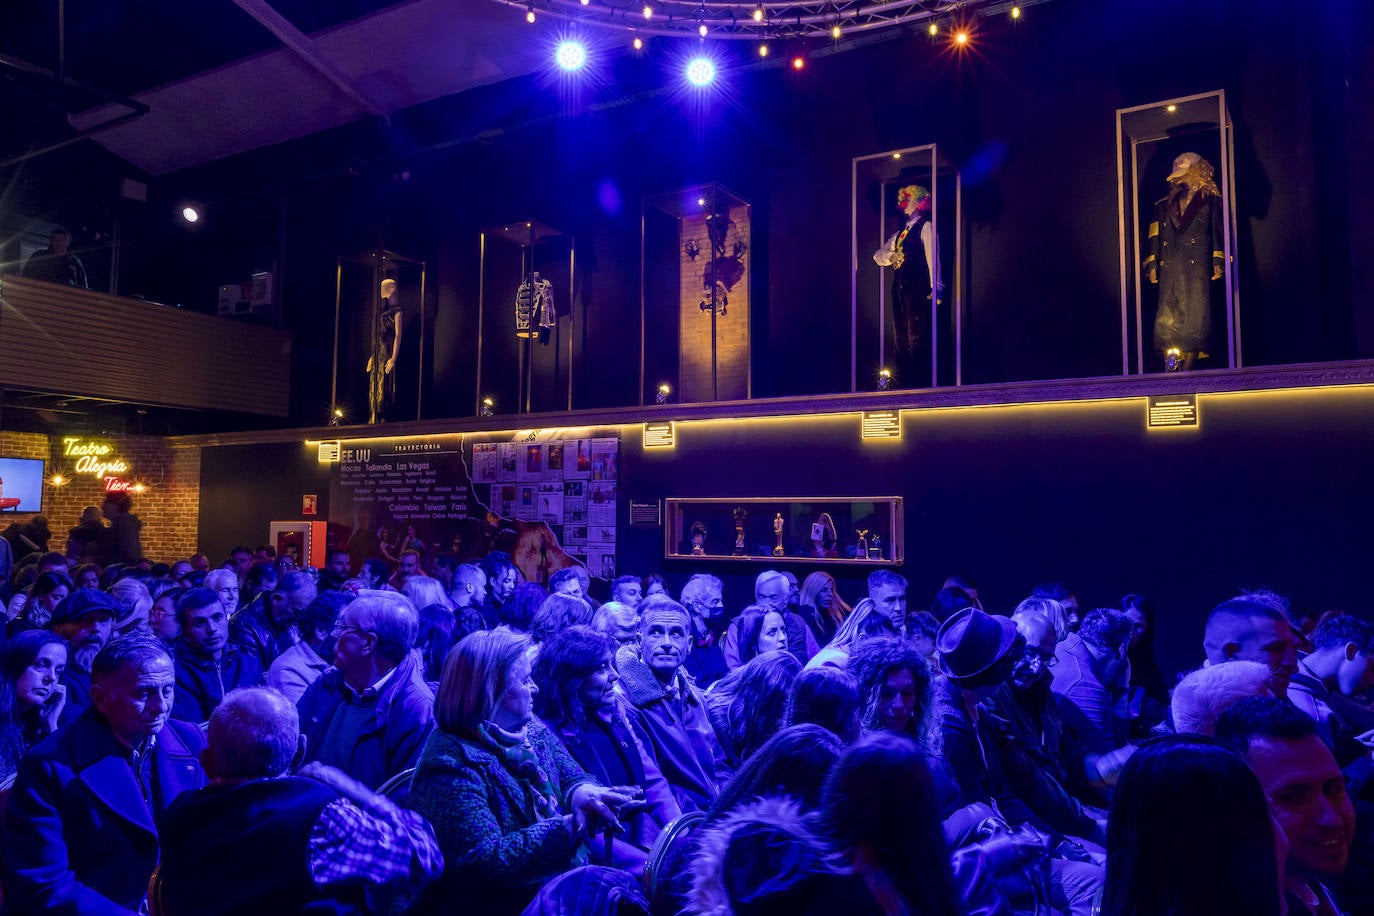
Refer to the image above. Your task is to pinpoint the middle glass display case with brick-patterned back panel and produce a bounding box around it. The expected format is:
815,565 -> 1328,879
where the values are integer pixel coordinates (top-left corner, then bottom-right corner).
639,183 -> 753,404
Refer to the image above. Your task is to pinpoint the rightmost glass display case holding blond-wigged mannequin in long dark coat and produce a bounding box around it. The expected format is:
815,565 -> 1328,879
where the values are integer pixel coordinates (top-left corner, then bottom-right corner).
1117,91 -> 1243,375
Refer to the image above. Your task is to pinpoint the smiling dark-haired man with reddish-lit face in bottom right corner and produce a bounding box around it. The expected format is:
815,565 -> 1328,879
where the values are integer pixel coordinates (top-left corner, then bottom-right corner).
1216,696 -> 1370,916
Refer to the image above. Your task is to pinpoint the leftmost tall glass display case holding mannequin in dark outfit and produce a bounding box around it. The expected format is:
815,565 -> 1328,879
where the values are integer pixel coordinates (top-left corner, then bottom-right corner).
330,249 -> 429,423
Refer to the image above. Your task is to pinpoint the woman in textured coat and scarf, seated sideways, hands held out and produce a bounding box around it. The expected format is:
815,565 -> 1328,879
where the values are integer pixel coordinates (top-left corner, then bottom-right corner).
408,628 -> 633,915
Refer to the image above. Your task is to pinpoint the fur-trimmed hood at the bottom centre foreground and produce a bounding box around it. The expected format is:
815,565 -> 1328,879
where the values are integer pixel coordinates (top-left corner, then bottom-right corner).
686,798 -> 849,916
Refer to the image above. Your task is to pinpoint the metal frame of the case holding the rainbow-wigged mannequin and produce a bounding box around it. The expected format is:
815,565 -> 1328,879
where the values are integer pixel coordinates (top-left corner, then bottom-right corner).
849,143 -> 965,391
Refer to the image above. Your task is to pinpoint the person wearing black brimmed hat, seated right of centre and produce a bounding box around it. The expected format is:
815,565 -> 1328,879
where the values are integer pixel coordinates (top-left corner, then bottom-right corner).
936,607 -> 1102,915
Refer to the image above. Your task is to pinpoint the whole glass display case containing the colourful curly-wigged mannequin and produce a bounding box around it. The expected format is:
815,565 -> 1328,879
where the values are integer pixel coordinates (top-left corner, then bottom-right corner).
849,144 -> 965,391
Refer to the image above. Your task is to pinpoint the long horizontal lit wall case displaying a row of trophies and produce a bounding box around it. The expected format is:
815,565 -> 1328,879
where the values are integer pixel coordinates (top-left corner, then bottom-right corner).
664,496 -> 903,564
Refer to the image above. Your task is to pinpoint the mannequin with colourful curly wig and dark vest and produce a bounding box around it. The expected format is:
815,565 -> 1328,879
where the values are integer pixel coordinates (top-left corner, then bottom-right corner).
872,184 -> 940,378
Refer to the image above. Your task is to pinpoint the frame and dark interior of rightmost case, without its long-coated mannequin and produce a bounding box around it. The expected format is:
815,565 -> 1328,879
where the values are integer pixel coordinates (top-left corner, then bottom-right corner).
1117,91 -> 1243,375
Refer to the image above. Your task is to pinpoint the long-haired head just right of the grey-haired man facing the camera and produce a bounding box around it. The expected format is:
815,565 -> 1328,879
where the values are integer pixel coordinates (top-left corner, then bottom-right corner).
706,650 -> 801,773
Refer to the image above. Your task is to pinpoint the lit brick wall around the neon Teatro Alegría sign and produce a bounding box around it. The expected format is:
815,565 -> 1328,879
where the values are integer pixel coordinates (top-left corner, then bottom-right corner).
0,431 -> 201,562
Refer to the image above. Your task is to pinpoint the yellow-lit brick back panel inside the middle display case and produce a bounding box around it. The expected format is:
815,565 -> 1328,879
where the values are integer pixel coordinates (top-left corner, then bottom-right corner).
677,206 -> 753,402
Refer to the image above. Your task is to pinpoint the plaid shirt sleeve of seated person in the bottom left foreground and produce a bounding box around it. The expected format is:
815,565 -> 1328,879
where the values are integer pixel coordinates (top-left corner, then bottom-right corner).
311,798 -> 444,887
